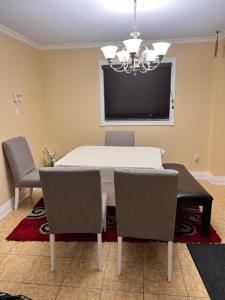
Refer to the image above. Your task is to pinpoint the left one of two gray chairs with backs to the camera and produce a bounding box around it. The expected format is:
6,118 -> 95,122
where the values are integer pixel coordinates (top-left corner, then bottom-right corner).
40,167 -> 107,271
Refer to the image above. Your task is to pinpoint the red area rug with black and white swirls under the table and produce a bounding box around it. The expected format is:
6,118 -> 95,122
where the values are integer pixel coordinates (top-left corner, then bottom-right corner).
6,199 -> 221,244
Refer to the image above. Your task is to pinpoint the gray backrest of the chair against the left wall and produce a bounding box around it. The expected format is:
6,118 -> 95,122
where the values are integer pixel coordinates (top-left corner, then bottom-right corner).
2,136 -> 35,185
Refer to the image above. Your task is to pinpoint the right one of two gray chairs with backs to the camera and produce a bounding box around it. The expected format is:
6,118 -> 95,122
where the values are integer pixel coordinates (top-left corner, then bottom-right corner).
114,169 -> 178,281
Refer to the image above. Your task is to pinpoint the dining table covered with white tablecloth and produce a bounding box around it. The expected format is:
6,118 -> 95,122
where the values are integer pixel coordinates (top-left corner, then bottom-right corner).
55,146 -> 163,205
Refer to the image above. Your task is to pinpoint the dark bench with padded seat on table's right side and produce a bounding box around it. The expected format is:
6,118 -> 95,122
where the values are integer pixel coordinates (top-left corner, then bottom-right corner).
163,163 -> 213,235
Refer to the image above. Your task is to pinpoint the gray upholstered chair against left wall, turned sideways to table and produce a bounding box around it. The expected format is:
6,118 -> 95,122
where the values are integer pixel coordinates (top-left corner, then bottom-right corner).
2,136 -> 41,209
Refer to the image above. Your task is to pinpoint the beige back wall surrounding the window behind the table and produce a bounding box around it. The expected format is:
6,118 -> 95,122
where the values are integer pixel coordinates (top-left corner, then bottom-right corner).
42,43 -> 214,170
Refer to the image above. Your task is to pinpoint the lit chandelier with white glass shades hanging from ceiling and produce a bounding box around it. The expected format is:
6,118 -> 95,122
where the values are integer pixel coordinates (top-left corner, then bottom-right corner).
101,0 -> 170,74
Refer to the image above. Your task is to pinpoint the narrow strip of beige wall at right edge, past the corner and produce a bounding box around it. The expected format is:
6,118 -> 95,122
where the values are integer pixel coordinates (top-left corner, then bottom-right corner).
210,40 -> 225,176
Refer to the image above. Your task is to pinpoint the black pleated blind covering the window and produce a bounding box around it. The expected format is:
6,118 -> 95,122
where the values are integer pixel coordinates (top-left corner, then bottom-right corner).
102,63 -> 172,120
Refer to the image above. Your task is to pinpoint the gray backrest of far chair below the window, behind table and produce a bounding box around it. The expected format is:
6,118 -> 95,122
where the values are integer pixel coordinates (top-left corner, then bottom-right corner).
105,131 -> 135,146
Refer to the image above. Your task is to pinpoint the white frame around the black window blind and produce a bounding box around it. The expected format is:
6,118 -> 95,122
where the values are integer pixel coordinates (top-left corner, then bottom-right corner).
99,57 -> 177,126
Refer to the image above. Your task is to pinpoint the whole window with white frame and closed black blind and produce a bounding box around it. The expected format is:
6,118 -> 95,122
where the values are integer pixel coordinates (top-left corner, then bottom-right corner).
99,58 -> 176,126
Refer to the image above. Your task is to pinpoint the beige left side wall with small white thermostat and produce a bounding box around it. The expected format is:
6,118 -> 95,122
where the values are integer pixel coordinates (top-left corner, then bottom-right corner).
0,34 -> 45,205
